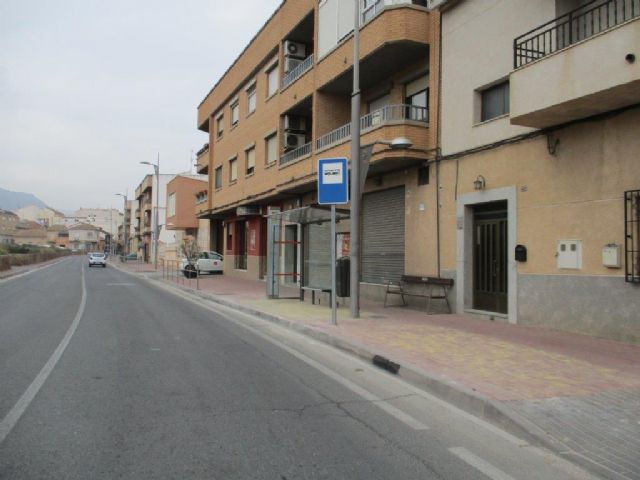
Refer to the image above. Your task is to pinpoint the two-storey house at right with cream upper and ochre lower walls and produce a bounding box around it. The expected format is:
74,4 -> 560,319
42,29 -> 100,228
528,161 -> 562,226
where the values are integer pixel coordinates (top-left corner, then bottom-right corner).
433,0 -> 640,341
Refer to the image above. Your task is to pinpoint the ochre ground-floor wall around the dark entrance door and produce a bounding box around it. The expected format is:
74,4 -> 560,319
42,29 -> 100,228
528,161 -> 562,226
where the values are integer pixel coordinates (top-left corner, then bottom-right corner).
440,109 -> 640,277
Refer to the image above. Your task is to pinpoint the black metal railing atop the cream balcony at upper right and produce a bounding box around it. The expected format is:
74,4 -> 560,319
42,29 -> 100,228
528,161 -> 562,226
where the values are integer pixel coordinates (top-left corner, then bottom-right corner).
513,0 -> 640,68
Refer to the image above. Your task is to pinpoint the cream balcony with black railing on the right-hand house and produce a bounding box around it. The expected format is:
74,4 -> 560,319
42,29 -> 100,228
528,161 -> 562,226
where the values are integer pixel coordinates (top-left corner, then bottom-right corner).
510,0 -> 640,128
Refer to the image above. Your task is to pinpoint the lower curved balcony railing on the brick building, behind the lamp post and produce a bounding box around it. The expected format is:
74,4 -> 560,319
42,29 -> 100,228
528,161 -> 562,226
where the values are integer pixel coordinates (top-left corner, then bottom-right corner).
316,104 -> 429,150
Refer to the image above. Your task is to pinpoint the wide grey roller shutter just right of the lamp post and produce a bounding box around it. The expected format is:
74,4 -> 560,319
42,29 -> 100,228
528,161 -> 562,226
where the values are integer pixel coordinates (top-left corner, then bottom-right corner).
362,187 -> 404,284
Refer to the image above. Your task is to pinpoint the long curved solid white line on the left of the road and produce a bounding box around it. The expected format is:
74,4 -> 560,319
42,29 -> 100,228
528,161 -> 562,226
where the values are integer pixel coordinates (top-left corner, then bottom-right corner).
0,268 -> 87,444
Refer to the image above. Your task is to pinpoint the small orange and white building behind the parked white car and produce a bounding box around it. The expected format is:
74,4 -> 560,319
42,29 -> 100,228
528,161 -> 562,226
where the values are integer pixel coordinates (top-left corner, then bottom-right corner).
165,174 -> 209,259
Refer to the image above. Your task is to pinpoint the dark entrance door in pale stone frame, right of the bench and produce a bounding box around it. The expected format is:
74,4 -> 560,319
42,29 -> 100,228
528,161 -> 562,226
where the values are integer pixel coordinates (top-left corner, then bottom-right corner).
473,201 -> 508,313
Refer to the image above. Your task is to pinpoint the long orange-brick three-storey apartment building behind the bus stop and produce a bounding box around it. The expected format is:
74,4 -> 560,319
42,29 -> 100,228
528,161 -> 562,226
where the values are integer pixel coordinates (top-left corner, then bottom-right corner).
197,0 -> 439,288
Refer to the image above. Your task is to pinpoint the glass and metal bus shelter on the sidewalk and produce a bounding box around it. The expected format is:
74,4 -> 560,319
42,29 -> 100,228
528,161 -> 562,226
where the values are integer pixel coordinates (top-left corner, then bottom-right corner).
266,205 -> 349,301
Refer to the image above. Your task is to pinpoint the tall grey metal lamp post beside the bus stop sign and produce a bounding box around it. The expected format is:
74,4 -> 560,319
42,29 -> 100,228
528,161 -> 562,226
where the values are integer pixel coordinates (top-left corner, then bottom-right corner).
350,0 -> 360,318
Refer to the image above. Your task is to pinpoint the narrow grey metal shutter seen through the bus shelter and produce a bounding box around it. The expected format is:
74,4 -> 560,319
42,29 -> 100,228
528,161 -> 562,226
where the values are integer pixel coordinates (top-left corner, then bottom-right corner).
304,222 -> 331,288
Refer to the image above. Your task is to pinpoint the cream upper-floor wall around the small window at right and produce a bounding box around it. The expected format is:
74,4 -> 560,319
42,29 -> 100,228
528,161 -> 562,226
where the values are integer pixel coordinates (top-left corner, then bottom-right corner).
440,0 -> 555,155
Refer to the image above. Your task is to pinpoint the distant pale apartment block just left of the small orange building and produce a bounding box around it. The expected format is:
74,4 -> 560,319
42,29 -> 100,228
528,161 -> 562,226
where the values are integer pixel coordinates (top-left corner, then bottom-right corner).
134,174 -> 175,262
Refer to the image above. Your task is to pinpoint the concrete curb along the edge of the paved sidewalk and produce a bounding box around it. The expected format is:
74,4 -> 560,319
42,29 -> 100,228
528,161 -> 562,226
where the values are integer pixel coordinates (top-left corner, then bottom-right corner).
115,267 -> 624,480
